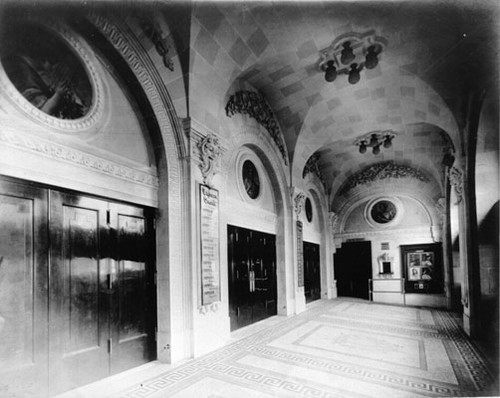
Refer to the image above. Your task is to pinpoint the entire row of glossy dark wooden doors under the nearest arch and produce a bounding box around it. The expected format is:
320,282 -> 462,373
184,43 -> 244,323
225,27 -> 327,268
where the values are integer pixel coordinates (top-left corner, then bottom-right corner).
0,179 -> 156,396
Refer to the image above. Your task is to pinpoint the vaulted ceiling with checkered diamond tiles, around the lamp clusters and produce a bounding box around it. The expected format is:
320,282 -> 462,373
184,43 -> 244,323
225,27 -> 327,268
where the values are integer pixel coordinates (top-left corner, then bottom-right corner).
191,1 -> 496,194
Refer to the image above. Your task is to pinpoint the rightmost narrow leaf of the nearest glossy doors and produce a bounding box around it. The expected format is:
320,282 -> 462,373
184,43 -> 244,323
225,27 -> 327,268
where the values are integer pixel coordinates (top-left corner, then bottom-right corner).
110,204 -> 156,373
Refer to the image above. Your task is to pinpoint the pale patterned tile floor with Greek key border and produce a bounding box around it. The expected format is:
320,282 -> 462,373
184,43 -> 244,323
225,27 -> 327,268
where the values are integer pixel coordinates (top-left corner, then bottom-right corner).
57,299 -> 498,398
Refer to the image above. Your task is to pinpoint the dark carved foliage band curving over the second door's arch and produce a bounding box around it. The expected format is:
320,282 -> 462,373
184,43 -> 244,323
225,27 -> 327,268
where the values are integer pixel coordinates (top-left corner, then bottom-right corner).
226,91 -> 288,165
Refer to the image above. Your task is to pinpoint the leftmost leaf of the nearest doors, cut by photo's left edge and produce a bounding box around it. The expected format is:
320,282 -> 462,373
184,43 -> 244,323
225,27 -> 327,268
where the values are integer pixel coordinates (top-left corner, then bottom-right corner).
0,179 -> 48,397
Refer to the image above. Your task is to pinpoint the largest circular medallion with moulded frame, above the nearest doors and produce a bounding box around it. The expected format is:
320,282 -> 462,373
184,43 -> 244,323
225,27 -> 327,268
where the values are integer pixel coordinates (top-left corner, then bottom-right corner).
0,13 -> 104,132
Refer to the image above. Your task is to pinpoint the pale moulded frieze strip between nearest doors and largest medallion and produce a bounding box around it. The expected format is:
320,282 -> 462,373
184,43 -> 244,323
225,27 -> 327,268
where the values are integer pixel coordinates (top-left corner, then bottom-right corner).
0,130 -> 159,188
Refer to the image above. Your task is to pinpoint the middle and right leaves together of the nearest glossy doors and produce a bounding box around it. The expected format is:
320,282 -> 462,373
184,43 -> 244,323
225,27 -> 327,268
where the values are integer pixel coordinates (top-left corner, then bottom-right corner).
49,191 -> 155,393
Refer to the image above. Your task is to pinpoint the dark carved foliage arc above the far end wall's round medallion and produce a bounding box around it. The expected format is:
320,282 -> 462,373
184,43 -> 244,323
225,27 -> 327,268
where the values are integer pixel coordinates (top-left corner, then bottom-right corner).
339,161 -> 429,195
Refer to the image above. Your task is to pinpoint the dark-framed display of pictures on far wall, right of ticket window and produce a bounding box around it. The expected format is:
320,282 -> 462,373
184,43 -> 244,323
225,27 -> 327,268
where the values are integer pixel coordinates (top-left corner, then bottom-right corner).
401,243 -> 443,293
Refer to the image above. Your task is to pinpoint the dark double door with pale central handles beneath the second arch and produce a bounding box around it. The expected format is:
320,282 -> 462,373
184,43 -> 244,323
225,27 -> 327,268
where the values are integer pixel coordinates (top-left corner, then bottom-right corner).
228,225 -> 277,331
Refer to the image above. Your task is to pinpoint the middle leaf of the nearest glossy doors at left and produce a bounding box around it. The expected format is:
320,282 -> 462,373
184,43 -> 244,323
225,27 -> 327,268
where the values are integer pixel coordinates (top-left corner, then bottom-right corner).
50,191 -> 109,393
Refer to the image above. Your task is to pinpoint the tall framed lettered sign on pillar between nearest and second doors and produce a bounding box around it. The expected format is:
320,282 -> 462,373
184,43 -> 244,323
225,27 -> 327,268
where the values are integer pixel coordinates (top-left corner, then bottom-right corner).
200,185 -> 220,305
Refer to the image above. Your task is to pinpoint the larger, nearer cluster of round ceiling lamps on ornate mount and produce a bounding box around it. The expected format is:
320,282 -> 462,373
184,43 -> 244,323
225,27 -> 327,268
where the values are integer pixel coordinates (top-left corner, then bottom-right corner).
319,30 -> 387,84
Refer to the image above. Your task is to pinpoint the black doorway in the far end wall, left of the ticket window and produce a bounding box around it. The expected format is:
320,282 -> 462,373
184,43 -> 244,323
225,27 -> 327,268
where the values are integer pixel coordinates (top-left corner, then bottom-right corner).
334,241 -> 372,300
